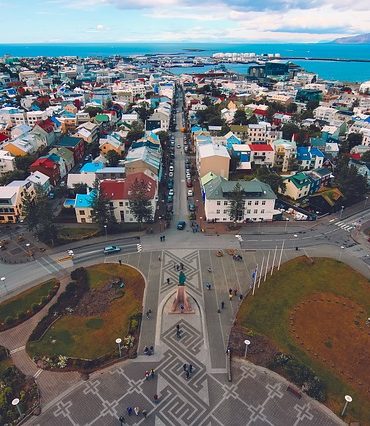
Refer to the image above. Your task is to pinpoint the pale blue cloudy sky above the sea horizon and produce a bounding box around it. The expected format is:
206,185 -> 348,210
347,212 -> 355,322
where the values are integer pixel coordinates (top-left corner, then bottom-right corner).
0,0 -> 370,43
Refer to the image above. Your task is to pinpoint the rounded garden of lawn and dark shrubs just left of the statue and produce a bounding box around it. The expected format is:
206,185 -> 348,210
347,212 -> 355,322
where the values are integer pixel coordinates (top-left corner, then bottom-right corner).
27,263 -> 145,371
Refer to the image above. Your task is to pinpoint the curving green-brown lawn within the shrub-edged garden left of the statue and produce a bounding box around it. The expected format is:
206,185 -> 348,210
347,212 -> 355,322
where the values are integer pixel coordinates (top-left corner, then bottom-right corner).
27,263 -> 145,359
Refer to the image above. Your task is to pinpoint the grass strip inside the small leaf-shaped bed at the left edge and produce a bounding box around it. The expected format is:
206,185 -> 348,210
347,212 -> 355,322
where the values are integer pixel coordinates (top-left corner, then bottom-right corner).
0,279 -> 57,322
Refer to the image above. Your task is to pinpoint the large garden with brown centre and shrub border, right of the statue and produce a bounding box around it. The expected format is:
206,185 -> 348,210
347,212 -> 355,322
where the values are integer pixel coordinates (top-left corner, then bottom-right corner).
230,257 -> 370,424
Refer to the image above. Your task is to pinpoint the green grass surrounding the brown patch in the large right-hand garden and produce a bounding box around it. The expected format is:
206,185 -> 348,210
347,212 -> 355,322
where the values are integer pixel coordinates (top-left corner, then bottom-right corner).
237,258 -> 370,424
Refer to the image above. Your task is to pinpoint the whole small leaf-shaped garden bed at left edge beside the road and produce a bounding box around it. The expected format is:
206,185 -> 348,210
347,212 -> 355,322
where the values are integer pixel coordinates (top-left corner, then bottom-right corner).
0,279 -> 59,331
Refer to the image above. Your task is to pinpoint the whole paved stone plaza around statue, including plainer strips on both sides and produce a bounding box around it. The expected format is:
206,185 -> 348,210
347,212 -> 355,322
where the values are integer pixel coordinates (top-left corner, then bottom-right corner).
28,250 -> 342,426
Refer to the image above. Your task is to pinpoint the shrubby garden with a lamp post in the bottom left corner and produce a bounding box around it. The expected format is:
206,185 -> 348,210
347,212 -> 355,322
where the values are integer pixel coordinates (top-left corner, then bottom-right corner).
0,346 -> 39,425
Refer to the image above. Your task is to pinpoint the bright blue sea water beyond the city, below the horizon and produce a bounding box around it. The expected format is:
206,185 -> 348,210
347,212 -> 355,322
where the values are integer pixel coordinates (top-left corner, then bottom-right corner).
0,43 -> 370,81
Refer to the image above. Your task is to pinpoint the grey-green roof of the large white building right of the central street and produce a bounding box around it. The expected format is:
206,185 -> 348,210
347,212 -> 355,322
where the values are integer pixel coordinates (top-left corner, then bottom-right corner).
204,176 -> 276,200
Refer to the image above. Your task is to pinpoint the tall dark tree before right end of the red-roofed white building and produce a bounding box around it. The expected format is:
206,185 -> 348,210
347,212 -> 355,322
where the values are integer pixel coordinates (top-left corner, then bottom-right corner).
129,179 -> 153,226
